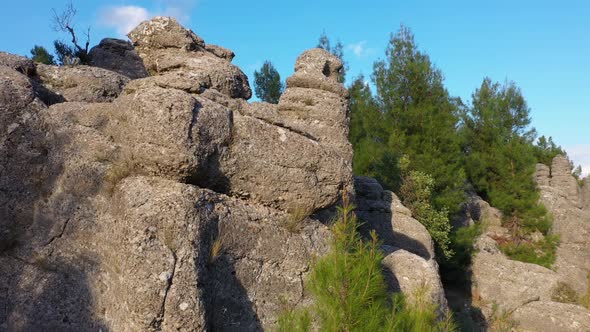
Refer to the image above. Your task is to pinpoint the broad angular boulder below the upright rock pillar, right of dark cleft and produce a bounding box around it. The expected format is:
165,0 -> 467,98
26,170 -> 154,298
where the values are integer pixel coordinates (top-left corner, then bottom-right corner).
220,114 -> 352,210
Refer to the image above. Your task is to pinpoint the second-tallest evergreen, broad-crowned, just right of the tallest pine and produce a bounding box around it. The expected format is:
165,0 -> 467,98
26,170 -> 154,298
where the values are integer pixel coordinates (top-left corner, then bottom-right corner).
463,78 -> 551,235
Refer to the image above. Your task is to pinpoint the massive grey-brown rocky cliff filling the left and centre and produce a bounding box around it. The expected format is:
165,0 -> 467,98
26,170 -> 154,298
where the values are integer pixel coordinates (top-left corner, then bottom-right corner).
0,17 -> 446,331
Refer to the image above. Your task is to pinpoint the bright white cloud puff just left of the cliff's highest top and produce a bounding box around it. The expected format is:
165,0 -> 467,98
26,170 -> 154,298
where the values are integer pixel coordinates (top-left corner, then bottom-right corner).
99,6 -> 150,35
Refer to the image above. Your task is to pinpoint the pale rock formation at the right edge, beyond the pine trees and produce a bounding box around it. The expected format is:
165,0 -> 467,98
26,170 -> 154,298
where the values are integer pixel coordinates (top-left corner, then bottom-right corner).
472,156 -> 590,331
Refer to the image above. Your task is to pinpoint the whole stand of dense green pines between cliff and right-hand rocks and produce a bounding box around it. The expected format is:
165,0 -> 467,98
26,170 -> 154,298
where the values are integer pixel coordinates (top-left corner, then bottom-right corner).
349,26 -> 564,273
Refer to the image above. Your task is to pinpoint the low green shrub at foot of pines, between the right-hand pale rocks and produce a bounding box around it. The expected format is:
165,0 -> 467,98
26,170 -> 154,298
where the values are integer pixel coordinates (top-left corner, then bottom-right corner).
500,235 -> 559,268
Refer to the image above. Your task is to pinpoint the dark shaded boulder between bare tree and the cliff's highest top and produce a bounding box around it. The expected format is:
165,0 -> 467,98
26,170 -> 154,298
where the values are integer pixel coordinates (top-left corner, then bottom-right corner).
89,38 -> 149,79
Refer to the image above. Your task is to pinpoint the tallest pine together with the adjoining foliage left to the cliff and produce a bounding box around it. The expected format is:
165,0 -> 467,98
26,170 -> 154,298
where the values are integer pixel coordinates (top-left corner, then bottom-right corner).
350,27 -> 465,213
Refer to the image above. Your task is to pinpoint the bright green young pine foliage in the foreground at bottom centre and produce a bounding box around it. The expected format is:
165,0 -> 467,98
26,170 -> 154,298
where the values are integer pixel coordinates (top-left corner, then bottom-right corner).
278,198 -> 455,331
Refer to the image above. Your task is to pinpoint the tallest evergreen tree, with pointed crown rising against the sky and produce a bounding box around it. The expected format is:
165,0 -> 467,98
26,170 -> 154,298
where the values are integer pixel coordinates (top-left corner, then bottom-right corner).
373,26 -> 465,213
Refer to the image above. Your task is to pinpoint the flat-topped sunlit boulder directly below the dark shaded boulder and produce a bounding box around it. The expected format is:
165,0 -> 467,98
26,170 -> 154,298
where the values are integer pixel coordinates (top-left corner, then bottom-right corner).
37,63 -> 129,103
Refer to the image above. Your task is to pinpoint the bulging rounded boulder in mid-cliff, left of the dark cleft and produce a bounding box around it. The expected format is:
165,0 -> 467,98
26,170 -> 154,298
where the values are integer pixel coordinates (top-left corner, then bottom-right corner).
110,87 -> 232,183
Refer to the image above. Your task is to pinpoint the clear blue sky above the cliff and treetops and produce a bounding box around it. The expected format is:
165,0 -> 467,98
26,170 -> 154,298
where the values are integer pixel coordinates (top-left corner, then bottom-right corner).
0,0 -> 590,172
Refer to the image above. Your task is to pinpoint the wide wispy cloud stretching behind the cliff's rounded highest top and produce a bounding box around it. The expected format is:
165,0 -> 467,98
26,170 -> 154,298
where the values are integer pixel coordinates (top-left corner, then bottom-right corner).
98,0 -> 197,36
